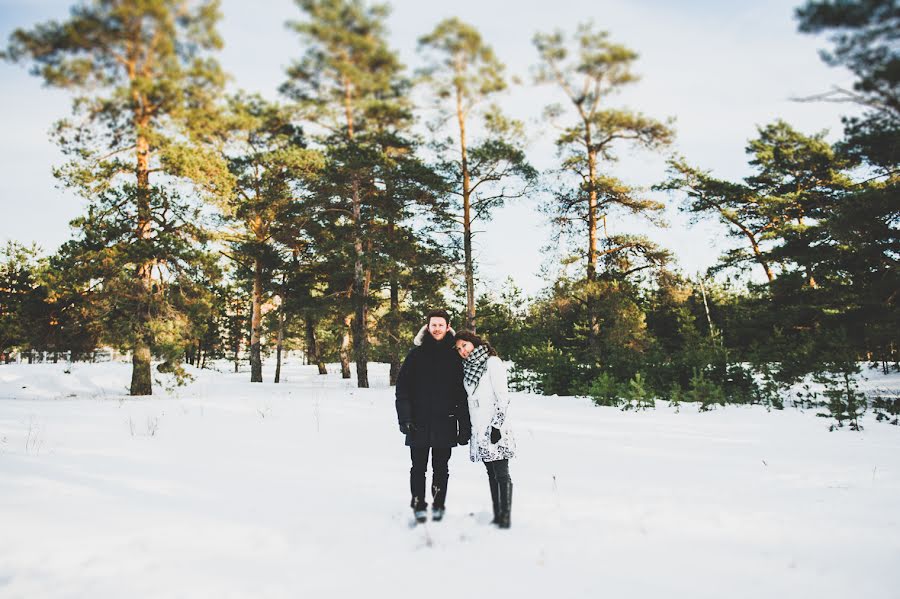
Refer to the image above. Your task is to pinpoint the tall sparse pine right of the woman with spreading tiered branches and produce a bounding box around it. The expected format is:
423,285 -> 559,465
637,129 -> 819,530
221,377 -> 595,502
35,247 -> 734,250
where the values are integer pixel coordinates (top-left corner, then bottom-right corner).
533,23 -> 673,368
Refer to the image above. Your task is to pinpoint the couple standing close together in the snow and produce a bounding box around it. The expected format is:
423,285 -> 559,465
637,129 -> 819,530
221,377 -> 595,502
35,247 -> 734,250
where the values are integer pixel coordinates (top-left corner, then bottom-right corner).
396,310 -> 515,528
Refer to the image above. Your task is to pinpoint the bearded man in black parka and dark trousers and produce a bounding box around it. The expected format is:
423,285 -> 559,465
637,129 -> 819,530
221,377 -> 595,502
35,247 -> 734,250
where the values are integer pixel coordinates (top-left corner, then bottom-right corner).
396,310 -> 472,522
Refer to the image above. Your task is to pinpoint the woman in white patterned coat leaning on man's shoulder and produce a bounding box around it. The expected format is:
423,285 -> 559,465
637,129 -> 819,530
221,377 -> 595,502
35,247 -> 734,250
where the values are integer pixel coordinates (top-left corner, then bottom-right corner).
454,331 -> 516,528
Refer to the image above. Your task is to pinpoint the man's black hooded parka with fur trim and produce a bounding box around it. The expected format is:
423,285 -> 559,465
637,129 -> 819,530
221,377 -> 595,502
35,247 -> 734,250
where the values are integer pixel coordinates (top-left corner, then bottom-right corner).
396,331 -> 472,447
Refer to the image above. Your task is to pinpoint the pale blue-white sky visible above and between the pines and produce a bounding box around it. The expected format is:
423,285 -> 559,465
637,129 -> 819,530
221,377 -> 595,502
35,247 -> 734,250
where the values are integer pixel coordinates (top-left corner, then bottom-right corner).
0,0 -> 852,295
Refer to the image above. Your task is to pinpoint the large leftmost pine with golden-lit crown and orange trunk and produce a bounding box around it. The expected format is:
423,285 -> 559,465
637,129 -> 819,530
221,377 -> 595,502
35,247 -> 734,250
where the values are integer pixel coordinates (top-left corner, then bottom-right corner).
4,0 -> 229,395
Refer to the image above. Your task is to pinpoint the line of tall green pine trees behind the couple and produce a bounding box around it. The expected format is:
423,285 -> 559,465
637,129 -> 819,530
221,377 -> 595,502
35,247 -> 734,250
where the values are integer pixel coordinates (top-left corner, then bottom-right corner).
0,0 -> 900,426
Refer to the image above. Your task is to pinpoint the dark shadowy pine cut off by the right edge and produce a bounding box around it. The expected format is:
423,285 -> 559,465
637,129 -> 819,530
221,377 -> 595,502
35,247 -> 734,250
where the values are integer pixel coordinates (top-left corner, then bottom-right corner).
796,0 -> 900,366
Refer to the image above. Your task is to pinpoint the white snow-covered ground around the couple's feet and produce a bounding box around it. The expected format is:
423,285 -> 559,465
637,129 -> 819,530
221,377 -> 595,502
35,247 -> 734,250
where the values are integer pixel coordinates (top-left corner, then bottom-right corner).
0,363 -> 900,599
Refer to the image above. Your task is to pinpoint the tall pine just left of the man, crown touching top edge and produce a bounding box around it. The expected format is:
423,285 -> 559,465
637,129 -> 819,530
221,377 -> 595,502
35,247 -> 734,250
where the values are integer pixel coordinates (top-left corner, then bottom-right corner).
282,0 -> 402,387
